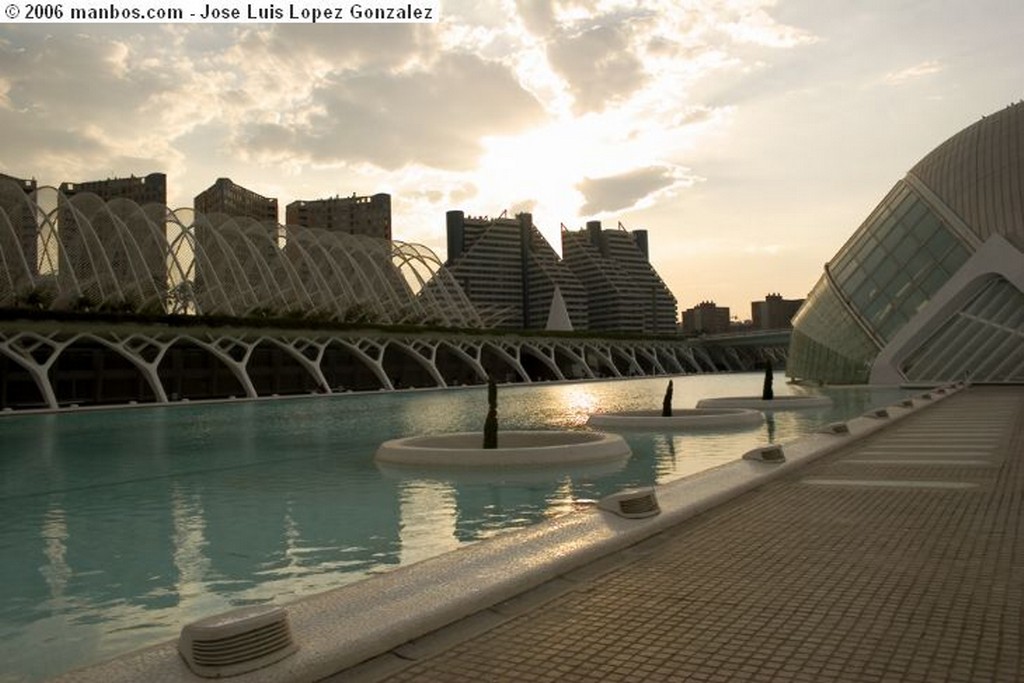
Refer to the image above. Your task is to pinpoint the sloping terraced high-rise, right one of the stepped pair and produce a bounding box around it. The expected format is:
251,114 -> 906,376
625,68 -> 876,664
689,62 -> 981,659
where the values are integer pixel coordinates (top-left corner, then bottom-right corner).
562,220 -> 677,335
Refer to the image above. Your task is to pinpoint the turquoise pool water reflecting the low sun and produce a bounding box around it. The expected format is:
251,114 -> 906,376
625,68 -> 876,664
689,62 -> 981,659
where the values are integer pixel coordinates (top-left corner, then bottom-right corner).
0,374 -> 901,683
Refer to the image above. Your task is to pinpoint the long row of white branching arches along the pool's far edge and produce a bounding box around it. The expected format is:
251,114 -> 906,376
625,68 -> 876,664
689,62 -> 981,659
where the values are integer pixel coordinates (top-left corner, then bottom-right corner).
0,321 -> 790,411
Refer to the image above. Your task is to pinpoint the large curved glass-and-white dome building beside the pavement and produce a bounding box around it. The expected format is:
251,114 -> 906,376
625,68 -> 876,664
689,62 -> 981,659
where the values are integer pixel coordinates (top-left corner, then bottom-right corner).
786,101 -> 1024,384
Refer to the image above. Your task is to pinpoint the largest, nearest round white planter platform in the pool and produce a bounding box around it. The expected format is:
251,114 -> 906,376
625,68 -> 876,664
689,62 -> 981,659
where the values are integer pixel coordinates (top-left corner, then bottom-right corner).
376,431 -> 632,467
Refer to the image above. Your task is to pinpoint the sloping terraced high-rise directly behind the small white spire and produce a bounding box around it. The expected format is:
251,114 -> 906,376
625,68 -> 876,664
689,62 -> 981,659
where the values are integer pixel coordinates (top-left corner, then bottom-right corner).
445,211 -> 588,330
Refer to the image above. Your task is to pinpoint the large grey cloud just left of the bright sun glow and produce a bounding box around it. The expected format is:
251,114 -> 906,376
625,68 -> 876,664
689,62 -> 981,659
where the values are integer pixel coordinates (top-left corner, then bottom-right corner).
238,54 -> 544,170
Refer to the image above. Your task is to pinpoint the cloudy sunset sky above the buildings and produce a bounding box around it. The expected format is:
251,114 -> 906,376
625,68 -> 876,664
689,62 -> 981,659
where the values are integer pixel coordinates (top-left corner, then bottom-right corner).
0,0 -> 1024,319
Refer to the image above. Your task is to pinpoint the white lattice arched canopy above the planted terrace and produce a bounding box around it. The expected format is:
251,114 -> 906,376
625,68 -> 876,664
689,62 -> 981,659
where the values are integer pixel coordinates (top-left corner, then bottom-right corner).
0,180 -> 483,328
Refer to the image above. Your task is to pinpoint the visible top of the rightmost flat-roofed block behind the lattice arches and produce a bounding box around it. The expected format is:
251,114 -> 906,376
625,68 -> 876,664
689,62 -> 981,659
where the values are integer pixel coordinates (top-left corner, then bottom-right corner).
285,193 -> 391,240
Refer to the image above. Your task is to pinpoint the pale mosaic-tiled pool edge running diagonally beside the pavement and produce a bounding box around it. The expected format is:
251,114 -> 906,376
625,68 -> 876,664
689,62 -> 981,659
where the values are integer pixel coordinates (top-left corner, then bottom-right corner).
52,383 -> 966,683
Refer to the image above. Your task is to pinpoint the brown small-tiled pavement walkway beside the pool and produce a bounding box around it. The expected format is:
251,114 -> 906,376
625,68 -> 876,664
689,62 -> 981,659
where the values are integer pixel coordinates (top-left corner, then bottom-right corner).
331,387 -> 1024,683
